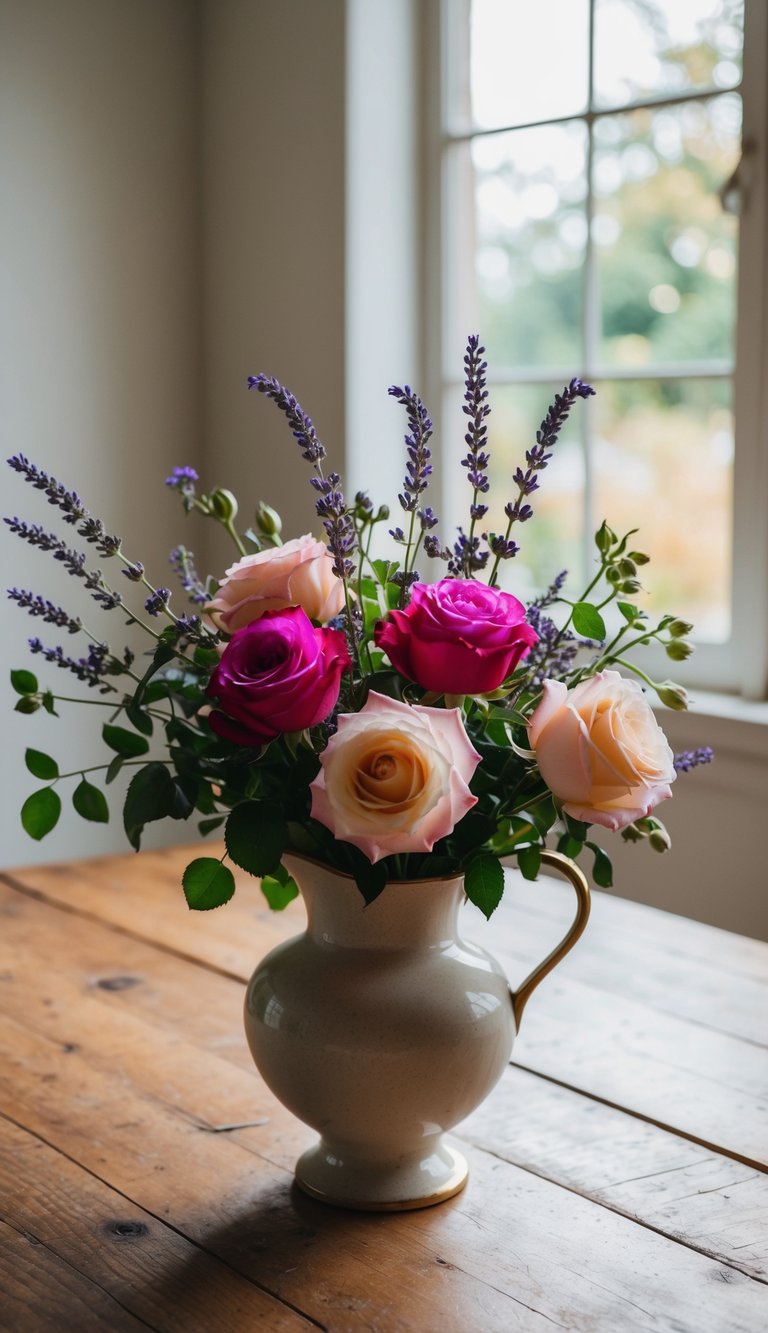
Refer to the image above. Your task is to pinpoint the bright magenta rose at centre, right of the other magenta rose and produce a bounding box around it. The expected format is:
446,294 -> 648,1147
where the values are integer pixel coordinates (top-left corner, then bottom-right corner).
375,579 -> 539,694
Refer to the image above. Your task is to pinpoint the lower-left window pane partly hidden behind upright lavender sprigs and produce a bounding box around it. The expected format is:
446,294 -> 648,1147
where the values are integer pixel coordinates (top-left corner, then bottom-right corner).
440,384 -> 585,601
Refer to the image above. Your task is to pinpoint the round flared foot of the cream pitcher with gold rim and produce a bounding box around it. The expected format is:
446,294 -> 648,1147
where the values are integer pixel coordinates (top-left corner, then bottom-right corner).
296,1141 -> 469,1213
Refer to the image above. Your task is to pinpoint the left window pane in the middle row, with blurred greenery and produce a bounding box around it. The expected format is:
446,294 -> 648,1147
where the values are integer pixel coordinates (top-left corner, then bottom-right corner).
464,121 -> 587,373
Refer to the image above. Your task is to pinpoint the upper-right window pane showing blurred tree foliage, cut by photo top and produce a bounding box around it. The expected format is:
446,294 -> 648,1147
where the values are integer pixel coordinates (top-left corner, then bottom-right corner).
595,0 -> 744,107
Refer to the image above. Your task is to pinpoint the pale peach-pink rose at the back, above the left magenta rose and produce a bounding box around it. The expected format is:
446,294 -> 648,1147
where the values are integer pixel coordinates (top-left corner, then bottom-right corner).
207,533 -> 344,635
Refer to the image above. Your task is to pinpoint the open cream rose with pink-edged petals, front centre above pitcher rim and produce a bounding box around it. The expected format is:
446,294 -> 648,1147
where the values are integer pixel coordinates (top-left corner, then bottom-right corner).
311,690 -> 480,861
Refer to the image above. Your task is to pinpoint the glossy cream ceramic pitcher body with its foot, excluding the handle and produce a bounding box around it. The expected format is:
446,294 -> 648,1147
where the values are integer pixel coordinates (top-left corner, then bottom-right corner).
245,857 -> 515,1209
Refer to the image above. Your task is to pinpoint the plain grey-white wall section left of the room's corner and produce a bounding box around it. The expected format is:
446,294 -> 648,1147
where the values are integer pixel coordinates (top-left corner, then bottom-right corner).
0,0 -> 201,865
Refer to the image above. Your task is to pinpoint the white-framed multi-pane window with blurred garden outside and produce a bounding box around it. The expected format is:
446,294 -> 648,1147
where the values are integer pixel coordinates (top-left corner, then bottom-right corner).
427,0 -> 768,697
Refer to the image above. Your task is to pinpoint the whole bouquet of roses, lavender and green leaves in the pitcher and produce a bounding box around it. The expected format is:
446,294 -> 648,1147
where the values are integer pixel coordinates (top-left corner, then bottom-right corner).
5,336 -> 712,917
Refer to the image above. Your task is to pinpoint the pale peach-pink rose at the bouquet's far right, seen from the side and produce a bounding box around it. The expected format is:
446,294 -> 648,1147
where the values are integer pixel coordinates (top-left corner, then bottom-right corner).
528,670 -> 676,829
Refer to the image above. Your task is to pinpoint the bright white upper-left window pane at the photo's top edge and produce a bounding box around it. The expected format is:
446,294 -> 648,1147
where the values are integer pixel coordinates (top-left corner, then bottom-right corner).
469,0 -> 589,129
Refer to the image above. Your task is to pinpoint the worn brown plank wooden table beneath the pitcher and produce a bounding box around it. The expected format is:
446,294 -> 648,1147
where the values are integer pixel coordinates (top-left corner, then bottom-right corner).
0,849 -> 768,1333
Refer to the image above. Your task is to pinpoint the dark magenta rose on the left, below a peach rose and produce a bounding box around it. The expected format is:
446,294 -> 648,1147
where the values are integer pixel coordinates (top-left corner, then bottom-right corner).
207,607 -> 352,745
